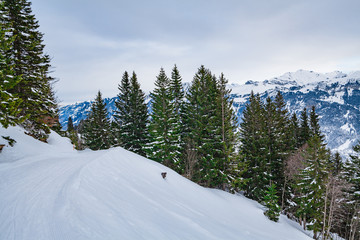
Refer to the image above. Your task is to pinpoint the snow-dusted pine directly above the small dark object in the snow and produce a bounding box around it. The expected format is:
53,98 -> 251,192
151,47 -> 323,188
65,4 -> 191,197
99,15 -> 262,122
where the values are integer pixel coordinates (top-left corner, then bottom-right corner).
149,68 -> 178,168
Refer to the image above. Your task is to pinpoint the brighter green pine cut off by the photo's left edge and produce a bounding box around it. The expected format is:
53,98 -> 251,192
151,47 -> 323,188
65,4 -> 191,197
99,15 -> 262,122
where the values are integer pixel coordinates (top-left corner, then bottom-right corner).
0,2 -> 25,128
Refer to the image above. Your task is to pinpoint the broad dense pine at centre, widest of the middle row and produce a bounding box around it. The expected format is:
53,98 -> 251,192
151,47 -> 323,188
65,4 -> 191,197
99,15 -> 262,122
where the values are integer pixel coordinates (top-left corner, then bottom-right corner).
183,66 -> 223,187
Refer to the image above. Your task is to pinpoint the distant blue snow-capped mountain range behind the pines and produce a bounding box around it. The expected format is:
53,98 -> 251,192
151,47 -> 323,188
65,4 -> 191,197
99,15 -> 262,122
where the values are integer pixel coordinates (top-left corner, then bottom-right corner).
60,70 -> 360,156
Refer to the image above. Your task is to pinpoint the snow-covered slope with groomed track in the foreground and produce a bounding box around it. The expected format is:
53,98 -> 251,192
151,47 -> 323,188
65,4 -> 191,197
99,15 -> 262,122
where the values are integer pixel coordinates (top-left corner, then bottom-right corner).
0,127 -> 311,240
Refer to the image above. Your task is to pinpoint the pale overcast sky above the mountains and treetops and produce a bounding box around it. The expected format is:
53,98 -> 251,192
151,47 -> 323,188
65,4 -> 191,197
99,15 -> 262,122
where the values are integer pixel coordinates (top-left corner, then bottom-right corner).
31,0 -> 360,105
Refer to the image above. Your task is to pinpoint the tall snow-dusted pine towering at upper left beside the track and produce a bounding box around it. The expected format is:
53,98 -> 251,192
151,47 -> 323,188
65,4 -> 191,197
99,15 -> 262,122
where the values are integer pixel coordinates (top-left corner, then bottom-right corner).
0,0 -> 57,140
